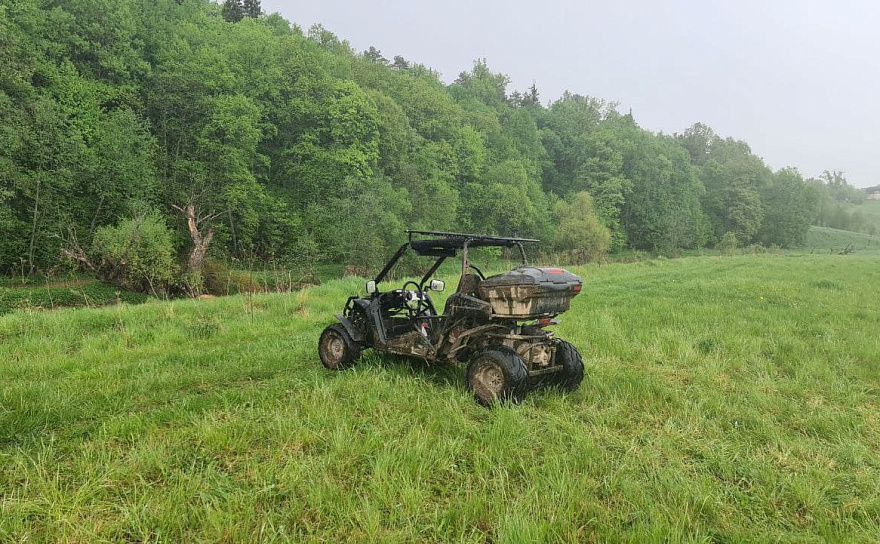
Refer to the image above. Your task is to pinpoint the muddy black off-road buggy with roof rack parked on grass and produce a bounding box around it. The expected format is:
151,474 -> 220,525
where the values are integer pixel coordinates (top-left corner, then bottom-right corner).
318,230 -> 584,405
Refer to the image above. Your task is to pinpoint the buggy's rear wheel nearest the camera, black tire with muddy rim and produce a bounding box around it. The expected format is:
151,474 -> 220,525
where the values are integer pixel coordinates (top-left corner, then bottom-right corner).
467,347 -> 529,406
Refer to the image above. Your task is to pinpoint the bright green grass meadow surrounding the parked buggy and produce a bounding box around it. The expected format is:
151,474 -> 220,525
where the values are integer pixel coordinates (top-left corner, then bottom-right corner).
0,253 -> 880,543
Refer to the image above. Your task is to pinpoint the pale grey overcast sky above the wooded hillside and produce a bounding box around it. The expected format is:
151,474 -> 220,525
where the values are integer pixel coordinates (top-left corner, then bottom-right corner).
263,0 -> 880,187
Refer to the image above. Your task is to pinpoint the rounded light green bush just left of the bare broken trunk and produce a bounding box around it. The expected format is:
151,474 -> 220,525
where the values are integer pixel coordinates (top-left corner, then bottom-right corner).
92,214 -> 178,295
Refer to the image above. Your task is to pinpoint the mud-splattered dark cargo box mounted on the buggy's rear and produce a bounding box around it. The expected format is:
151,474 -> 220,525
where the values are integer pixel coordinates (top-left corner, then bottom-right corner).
480,266 -> 582,319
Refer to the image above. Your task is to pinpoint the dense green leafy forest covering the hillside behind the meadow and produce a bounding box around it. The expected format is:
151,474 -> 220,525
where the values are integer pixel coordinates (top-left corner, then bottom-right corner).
0,0 -> 874,291
